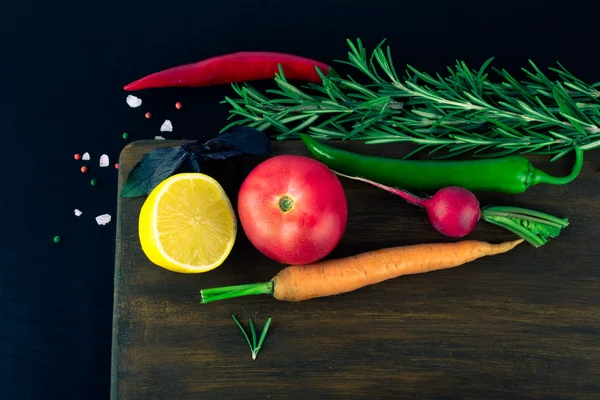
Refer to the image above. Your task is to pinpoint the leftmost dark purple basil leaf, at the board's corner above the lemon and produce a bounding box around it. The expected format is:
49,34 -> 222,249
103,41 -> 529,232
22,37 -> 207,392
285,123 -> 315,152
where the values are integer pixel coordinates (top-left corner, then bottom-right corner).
121,146 -> 188,197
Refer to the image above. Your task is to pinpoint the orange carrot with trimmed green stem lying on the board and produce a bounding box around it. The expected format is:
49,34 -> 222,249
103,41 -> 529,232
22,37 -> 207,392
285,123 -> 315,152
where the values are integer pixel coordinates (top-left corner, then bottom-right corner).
200,239 -> 523,304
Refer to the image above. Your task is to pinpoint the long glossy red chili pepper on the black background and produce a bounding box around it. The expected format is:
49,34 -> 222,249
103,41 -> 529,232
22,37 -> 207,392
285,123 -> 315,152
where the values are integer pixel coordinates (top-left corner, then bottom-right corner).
124,52 -> 331,90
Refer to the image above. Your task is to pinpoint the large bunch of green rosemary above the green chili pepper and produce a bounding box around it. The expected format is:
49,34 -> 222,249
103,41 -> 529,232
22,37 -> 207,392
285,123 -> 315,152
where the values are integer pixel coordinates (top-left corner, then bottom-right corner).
223,39 -> 600,161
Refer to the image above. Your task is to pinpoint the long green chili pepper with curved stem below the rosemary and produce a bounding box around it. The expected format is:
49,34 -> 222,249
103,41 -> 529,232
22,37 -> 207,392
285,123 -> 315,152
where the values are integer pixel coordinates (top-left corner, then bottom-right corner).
300,134 -> 583,194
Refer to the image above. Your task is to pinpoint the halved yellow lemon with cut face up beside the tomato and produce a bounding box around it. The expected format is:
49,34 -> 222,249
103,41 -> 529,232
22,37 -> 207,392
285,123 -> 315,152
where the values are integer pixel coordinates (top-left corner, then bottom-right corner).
138,173 -> 237,274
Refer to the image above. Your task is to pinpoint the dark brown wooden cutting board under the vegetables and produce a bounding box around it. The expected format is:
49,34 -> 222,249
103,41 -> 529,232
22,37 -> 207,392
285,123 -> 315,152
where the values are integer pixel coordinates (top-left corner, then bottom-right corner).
112,141 -> 600,400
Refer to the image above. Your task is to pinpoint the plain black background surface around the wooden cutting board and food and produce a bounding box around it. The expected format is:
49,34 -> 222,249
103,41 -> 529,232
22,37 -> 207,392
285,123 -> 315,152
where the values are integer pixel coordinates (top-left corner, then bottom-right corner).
0,0 -> 600,400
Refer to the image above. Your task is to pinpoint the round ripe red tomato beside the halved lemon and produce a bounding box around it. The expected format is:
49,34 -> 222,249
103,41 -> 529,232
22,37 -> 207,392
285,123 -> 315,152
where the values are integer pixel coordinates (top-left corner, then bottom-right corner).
238,155 -> 348,265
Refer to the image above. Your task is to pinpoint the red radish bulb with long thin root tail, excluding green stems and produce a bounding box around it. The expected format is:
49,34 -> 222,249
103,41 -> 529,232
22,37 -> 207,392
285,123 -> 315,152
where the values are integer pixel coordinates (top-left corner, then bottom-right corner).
336,172 -> 481,237
